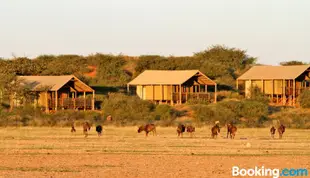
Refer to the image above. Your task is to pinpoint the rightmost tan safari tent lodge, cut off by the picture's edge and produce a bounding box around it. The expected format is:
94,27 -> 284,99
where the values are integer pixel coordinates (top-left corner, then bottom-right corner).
236,65 -> 310,106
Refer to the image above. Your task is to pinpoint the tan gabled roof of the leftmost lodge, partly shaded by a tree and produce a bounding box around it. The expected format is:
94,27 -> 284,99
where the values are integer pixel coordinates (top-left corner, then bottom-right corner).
17,75 -> 93,92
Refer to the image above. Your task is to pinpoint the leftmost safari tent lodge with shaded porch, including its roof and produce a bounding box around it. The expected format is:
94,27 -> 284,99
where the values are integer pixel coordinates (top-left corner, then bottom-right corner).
15,75 -> 95,112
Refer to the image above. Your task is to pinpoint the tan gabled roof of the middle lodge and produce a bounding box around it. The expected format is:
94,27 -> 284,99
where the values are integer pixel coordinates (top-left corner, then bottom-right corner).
128,70 -> 216,85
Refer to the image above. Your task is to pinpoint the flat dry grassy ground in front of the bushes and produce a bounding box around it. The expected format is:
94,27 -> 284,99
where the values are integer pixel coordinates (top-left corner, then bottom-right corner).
0,127 -> 310,177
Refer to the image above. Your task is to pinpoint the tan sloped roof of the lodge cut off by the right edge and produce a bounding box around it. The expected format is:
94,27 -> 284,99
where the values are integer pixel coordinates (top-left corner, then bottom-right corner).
238,65 -> 310,80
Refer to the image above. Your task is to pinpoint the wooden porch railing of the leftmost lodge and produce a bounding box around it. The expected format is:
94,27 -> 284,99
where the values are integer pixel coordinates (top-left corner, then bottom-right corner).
48,98 -> 92,110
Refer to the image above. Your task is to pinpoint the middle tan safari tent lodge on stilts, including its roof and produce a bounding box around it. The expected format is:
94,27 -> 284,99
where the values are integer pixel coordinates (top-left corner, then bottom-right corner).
127,70 -> 217,105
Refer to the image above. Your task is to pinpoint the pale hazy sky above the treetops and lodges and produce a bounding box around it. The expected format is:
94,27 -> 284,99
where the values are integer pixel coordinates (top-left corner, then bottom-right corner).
0,0 -> 310,64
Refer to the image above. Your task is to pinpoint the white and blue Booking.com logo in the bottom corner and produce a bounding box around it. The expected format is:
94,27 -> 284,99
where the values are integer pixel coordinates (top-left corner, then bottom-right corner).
232,166 -> 308,178
